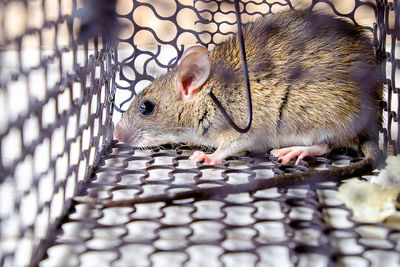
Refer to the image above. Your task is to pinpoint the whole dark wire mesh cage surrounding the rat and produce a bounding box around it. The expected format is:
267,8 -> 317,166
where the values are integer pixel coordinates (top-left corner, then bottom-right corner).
0,0 -> 400,266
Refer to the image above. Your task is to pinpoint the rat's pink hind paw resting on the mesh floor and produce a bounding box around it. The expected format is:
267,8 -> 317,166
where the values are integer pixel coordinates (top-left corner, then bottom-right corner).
271,145 -> 329,165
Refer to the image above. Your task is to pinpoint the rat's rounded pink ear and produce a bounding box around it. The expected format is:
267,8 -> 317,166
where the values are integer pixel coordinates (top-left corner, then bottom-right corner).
176,45 -> 210,101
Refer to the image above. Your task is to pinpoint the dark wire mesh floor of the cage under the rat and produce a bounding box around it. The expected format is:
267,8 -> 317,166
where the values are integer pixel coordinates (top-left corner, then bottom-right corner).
41,143 -> 400,266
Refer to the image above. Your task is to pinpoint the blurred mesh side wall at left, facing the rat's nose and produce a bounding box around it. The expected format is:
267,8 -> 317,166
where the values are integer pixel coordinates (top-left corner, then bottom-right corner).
0,0 -> 116,266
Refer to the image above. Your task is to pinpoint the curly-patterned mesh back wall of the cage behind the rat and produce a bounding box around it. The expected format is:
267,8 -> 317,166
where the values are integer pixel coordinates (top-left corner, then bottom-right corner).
114,0 -> 382,118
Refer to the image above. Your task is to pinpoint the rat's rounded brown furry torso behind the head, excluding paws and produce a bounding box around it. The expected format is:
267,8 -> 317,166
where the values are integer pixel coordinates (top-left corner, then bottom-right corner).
210,11 -> 381,151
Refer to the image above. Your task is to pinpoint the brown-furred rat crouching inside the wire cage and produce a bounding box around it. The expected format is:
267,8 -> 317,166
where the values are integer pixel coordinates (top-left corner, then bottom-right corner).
110,10 -> 383,205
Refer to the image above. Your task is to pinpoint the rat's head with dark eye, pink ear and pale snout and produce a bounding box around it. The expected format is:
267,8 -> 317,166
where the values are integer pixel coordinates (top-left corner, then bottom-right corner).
114,46 -> 210,146
